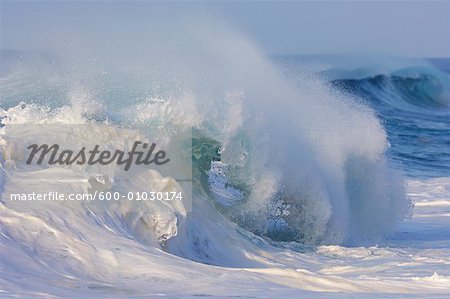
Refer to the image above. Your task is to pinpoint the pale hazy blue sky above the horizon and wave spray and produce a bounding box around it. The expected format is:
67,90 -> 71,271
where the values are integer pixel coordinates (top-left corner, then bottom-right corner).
1,1 -> 450,57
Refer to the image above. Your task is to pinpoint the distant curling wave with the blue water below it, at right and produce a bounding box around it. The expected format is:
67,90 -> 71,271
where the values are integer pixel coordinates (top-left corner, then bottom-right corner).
331,65 -> 450,177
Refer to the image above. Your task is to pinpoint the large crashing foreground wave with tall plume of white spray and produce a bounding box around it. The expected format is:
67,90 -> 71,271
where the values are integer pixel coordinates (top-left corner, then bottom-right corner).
0,18 -> 411,275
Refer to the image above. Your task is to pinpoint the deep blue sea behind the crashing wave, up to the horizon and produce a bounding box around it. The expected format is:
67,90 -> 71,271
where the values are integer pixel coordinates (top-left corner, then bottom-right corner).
274,56 -> 450,178
